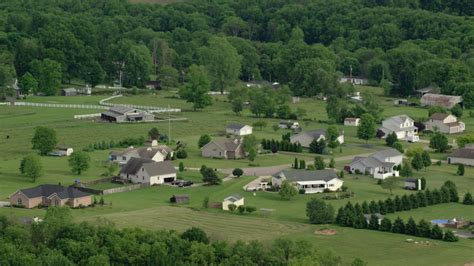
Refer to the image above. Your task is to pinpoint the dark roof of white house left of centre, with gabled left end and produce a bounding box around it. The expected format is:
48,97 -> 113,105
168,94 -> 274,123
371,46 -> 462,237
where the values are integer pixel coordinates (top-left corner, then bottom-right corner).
120,158 -> 176,176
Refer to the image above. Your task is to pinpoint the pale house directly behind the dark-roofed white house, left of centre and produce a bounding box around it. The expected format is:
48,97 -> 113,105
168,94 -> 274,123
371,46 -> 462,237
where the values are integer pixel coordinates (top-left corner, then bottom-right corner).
109,145 -> 173,164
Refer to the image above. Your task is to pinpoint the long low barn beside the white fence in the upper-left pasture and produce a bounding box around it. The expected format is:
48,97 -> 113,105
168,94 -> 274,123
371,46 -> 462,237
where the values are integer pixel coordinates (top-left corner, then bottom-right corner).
101,105 -> 155,123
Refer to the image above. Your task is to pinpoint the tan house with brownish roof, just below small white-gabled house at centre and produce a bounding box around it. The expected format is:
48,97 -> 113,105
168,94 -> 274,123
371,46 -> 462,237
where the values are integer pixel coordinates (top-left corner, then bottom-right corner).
201,138 -> 245,159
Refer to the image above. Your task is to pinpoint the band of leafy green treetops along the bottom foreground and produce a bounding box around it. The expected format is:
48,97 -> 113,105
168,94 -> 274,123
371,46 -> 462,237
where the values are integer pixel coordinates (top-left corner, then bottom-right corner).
0,207 -> 364,266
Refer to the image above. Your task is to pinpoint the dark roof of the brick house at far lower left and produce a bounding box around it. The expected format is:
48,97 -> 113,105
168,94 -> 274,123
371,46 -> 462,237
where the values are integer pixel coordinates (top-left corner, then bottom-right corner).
20,184 -> 90,199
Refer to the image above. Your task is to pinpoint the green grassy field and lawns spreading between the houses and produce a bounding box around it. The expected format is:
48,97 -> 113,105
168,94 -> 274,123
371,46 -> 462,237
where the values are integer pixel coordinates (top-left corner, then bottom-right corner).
0,87 -> 474,265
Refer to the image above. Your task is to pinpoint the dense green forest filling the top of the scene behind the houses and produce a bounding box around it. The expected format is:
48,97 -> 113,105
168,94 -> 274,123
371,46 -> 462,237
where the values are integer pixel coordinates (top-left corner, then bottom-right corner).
0,0 -> 474,106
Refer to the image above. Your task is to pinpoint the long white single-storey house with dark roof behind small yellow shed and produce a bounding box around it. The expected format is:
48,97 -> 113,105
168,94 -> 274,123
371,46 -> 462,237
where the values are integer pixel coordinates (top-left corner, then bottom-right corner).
272,169 -> 344,194
